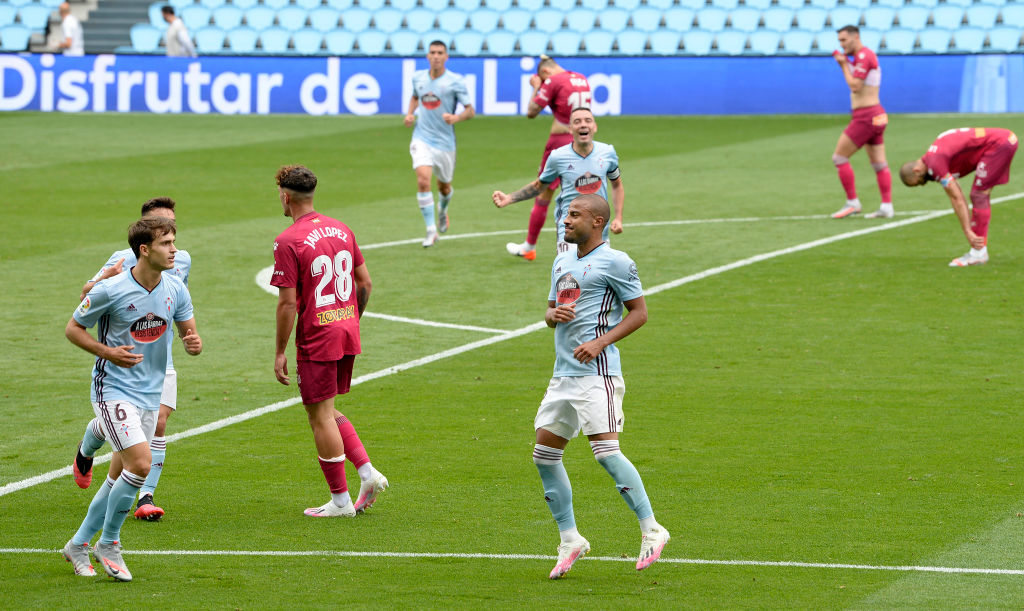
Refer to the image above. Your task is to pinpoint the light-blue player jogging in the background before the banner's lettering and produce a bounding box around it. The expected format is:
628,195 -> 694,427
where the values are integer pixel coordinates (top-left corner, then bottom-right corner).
404,40 -> 475,248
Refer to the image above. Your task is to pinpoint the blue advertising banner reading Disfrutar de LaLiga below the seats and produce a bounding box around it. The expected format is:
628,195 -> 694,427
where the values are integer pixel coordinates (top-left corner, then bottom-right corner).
0,53 -> 1024,115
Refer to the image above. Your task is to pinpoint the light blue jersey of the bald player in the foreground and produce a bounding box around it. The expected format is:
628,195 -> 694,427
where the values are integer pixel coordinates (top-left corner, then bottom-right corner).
548,243 -> 643,378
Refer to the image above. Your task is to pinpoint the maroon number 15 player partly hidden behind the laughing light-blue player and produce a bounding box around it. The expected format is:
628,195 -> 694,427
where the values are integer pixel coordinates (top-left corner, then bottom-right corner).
505,55 -> 593,261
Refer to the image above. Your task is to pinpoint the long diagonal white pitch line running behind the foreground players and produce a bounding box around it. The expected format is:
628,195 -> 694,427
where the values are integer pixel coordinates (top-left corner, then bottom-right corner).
0,200 -> 1024,496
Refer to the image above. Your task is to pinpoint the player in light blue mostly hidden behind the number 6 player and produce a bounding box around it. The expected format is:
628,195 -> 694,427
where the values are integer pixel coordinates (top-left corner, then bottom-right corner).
72,198 -> 191,521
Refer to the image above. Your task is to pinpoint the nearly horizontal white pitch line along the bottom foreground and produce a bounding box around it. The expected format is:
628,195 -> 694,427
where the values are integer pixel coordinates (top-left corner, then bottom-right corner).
0,548 -> 1024,575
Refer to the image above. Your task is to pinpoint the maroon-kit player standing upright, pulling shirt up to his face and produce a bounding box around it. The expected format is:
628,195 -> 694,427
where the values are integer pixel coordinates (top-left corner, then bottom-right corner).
831,26 -> 894,219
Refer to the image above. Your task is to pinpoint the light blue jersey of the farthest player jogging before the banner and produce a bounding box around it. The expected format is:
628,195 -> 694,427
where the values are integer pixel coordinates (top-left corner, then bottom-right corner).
413,70 -> 470,150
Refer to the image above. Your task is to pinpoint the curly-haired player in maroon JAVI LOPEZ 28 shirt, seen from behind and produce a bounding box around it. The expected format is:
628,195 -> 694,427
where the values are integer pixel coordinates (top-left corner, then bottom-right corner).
270,166 -> 388,518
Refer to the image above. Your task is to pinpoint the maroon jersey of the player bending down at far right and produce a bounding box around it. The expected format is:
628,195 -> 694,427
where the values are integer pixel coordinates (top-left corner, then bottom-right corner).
922,127 -> 1017,186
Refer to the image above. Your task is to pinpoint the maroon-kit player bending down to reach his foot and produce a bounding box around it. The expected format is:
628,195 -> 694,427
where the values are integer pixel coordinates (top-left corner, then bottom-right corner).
899,127 -> 1017,267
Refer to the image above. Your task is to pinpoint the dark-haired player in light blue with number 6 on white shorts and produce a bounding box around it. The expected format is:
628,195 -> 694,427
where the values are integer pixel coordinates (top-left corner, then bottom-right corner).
62,216 -> 203,581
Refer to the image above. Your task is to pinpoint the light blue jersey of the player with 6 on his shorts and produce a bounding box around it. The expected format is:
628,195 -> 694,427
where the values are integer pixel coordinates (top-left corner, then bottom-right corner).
74,271 -> 193,410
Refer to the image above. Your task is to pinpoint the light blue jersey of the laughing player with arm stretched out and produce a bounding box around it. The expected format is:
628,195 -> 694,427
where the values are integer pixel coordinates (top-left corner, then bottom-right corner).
539,142 -> 621,242
